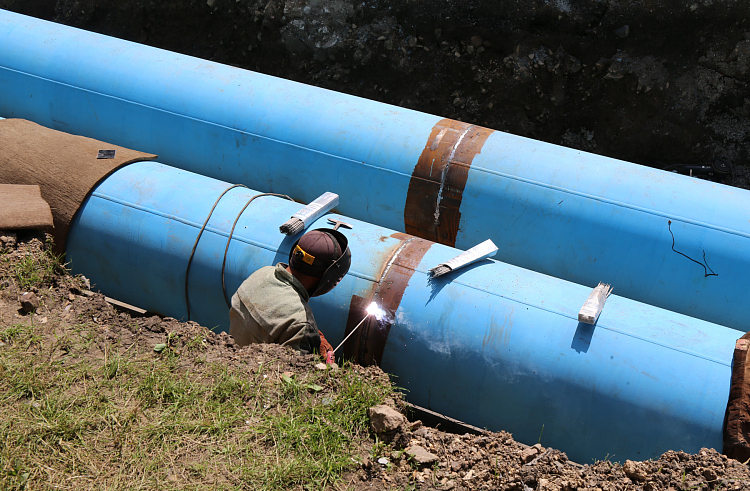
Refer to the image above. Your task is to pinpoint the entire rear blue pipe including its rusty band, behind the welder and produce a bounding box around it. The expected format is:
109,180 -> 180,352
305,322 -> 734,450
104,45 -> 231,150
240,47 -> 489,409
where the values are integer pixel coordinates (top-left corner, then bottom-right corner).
0,11 -> 750,331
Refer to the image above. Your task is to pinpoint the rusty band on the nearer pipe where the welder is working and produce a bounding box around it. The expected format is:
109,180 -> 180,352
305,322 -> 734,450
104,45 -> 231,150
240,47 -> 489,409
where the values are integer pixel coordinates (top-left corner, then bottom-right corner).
344,233 -> 433,366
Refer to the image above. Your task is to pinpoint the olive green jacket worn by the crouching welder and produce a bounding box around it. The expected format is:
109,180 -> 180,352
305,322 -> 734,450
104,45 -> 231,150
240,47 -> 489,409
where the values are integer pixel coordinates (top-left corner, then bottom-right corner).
229,263 -> 320,353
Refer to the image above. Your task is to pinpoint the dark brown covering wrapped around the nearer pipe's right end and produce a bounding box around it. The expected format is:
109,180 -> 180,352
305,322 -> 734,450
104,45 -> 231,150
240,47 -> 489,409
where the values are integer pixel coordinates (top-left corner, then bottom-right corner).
724,333 -> 750,462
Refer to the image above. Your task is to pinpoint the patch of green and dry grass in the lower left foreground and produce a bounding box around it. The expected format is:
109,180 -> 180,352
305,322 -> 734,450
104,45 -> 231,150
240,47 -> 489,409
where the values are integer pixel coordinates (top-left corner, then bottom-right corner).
0,324 -> 392,490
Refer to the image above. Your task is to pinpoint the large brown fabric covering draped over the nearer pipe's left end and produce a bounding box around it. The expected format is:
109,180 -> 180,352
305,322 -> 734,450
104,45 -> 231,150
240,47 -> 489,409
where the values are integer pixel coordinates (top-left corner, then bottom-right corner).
0,119 -> 156,251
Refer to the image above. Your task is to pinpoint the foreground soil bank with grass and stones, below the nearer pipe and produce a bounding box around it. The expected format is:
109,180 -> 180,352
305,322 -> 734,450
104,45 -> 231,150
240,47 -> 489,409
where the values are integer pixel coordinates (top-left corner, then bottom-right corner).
0,236 -> 750,491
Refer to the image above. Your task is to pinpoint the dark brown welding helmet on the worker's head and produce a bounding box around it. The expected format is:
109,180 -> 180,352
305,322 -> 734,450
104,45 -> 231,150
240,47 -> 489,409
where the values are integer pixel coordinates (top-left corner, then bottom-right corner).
289,228 -> 352,297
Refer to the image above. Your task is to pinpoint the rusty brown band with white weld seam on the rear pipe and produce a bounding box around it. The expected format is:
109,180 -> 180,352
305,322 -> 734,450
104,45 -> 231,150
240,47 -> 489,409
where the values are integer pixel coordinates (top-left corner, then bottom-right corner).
404,119 -> 493,247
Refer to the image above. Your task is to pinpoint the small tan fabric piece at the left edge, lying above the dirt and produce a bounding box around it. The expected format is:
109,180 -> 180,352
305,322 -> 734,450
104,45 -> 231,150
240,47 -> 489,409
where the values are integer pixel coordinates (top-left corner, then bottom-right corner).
0,184 -> 52,230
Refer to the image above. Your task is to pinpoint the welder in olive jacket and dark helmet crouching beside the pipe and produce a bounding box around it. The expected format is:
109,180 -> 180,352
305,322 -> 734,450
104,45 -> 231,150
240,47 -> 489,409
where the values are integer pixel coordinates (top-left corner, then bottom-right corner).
229,229 -> 351,355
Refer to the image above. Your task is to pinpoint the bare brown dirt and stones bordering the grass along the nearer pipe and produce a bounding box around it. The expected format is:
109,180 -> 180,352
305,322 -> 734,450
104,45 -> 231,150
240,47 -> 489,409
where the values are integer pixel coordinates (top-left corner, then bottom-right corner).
0,234 -> 750,491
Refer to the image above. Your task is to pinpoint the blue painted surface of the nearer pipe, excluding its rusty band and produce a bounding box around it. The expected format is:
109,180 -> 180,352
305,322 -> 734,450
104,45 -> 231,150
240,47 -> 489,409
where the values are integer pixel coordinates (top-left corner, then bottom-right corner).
67,162 -> 738,462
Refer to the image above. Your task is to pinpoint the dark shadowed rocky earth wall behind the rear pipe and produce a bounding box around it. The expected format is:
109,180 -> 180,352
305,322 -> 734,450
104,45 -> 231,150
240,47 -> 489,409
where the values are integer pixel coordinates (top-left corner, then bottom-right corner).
0,0 -> 750,187
